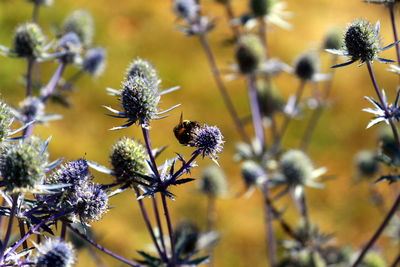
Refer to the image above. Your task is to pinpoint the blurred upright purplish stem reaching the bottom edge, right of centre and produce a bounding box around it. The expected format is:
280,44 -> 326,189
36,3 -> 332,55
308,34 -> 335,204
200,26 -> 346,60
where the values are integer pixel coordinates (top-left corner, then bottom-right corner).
262,183 -> 277,267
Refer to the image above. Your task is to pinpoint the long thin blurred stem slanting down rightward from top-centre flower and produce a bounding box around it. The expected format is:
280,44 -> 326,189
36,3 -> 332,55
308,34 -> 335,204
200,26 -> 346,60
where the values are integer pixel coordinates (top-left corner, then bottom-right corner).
199,34 -> 250,143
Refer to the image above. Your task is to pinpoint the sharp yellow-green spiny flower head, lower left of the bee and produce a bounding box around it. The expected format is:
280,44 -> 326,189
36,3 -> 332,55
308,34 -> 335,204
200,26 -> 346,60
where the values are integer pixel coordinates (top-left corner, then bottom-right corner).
110,137 -> 147,185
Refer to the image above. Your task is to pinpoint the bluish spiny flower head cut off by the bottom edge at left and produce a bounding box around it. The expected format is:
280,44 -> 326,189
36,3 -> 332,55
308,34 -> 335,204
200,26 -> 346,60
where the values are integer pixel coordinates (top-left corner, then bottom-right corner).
34,238 -> 76,267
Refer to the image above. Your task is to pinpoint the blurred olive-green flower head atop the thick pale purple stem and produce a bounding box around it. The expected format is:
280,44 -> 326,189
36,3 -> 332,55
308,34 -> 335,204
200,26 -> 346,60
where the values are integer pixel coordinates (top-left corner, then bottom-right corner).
236,34 -> 265,73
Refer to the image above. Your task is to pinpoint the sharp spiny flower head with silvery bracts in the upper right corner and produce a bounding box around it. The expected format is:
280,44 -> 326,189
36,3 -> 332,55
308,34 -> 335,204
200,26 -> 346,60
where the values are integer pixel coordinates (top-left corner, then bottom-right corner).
326,20 -> 396,68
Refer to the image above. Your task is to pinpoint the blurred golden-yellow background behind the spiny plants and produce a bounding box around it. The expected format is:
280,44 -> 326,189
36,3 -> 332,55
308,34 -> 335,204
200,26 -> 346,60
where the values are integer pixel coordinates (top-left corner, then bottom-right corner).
0,0 -> 398,266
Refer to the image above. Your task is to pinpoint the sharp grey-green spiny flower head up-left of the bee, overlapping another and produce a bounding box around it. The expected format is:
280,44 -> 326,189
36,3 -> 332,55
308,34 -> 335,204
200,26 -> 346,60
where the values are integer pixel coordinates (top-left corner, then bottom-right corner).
121,76 -> 160,125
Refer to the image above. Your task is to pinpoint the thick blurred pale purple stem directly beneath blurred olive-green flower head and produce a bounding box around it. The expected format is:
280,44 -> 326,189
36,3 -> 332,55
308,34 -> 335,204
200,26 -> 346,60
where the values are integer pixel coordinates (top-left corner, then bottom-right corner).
247,73 -> 266,151
